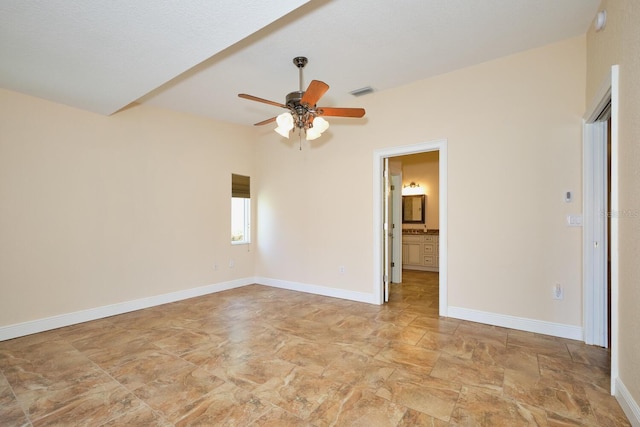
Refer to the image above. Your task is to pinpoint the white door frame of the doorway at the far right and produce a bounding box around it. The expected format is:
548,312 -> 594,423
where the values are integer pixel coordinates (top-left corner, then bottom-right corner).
582,65 -> 619,394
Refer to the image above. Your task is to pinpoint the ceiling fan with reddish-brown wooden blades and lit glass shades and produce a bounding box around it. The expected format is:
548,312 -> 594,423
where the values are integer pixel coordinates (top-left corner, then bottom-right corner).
238,56 -> 365,140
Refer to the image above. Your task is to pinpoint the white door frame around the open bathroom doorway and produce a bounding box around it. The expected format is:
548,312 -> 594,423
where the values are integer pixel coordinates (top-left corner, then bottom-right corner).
373,139 -> 449,316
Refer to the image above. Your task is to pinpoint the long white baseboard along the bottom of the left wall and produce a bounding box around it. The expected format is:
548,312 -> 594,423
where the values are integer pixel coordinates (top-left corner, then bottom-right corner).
0,277 -> 256,341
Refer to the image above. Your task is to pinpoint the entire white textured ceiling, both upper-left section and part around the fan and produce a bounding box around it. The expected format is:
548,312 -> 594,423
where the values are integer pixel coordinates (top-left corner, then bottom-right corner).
0,0 -> 600,124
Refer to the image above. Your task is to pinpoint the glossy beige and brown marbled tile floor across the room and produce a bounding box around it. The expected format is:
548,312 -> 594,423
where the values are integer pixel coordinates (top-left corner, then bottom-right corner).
0,271 -> 629,427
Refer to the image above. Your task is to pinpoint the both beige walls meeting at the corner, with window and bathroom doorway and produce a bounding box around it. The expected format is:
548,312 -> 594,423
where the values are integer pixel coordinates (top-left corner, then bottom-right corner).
0,37 -> 586,342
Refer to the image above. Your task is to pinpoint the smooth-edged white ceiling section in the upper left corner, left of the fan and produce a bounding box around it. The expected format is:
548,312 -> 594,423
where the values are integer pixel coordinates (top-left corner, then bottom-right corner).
0,0 -> 308,114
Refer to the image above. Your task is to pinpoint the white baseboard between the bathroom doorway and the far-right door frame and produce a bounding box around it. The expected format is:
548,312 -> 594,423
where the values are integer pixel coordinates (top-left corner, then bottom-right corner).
447,306 -> 584,341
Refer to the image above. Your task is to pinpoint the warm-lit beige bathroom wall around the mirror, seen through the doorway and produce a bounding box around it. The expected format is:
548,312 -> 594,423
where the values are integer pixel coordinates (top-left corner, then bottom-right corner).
397,151 -> 440,229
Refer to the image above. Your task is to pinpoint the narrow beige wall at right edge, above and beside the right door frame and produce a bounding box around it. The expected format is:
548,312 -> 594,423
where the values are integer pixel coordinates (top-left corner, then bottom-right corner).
587,0 -> 640,408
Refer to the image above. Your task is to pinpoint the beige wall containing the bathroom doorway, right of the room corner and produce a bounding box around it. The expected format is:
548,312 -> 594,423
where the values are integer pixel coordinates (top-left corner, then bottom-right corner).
256,37 -> 586,327
